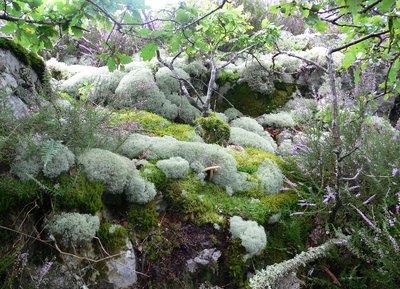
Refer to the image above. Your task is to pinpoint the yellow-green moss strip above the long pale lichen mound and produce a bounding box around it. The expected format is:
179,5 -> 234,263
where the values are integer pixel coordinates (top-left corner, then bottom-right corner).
111,111 -> 196,141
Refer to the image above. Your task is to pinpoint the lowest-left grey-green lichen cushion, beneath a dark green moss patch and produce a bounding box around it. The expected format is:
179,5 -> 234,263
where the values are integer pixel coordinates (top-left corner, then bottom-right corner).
47,213 -> 100,248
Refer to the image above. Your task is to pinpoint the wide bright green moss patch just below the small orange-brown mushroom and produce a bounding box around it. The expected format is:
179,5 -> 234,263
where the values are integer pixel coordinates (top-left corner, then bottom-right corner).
164,176 -> 297,224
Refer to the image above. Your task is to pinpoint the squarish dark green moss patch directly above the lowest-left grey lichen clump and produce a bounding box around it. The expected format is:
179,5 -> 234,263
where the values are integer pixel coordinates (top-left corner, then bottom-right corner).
57,172 -> 104,214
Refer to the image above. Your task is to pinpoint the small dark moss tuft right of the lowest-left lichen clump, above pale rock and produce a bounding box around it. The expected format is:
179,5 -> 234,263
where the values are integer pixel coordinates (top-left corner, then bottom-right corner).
97,223 -> 128,254
